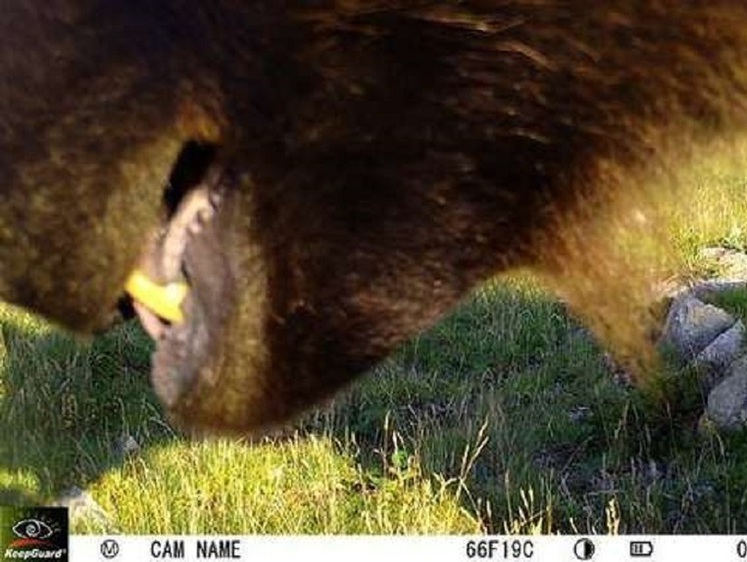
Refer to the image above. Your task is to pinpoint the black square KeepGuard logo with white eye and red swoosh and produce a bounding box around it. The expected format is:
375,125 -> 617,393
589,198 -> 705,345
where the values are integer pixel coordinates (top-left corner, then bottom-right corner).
0,506 -> 68,562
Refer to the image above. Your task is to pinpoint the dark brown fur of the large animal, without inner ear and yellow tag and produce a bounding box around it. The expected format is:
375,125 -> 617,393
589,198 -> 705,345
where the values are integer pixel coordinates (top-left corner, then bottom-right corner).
0,0 -> 747,431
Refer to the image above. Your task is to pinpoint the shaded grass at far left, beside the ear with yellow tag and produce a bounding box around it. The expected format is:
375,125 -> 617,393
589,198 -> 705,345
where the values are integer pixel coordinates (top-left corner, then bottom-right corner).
0,311 -> 175,505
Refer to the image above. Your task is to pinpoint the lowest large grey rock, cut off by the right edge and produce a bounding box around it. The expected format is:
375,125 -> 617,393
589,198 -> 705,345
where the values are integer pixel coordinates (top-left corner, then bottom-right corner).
706,356 -> 747,430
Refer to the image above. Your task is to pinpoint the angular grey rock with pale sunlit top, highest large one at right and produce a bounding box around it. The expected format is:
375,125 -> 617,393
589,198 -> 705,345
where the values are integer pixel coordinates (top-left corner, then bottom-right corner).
661,294 -> 736,362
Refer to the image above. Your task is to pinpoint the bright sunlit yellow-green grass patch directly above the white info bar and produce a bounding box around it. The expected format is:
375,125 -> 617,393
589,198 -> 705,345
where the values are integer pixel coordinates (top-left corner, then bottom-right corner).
76,437 -> 482,534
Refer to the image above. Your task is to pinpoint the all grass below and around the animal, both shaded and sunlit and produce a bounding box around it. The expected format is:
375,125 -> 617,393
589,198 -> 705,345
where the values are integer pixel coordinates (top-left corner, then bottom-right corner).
0,152 -> 747,533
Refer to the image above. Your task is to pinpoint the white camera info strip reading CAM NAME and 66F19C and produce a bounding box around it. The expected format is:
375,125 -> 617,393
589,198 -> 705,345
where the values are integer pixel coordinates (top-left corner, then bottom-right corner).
67,534 -> 747,562
